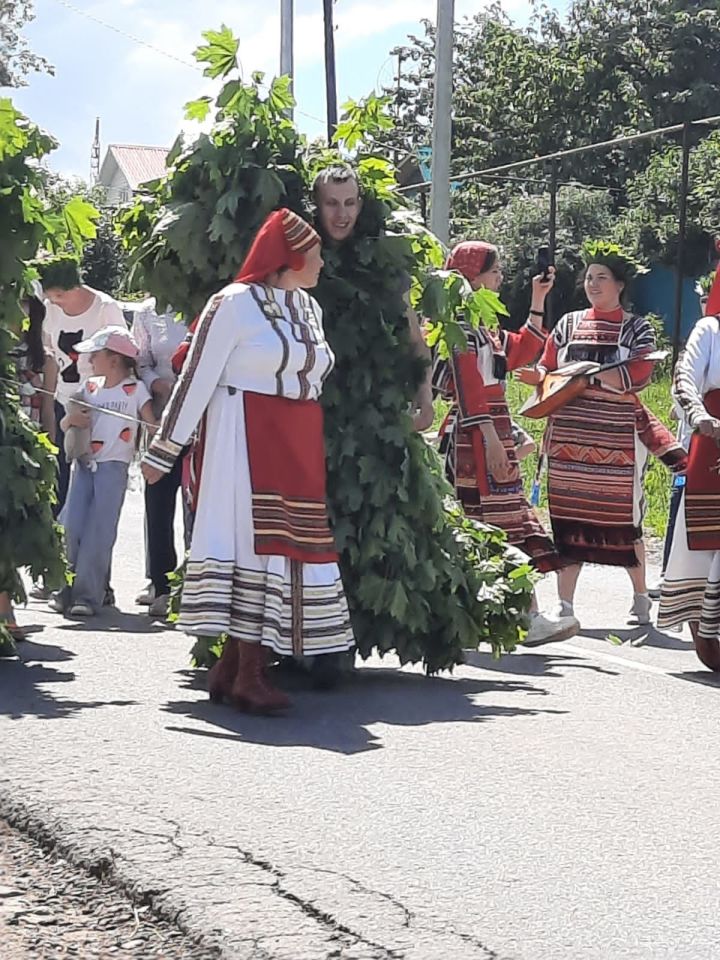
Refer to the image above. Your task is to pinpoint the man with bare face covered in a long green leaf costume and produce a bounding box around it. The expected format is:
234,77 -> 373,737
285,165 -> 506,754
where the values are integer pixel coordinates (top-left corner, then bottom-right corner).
306,164 -> 528,673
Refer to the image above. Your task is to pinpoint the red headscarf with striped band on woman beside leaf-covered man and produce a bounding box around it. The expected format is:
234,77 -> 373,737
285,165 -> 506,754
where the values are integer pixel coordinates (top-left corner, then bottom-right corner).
235,207 -> 320,283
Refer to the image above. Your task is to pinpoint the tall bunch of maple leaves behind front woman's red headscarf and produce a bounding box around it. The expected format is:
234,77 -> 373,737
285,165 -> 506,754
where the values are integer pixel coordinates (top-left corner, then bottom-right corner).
118,27 -> 303,320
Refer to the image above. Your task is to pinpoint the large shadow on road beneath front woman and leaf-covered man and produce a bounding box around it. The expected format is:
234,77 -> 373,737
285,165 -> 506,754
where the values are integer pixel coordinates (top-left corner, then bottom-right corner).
163,668 -> 566,755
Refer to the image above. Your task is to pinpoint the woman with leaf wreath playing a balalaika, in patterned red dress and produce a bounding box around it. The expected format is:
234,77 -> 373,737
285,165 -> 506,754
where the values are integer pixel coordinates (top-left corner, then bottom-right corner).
526,245 -> 685,624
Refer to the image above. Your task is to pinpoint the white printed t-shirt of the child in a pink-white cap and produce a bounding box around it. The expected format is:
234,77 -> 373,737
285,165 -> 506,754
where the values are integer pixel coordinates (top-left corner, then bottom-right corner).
80,377 -> 150,463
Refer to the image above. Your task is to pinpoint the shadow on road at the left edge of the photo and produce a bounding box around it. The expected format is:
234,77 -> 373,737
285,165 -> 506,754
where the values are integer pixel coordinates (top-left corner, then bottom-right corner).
0,641 -> 135,720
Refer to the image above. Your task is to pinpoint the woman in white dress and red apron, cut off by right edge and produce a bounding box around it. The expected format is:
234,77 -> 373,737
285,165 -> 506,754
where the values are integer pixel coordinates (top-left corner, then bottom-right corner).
658,304 -> 720,671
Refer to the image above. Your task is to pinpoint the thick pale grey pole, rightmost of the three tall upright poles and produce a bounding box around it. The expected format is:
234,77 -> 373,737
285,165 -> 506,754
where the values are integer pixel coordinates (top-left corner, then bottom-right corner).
430,0 -> 455,244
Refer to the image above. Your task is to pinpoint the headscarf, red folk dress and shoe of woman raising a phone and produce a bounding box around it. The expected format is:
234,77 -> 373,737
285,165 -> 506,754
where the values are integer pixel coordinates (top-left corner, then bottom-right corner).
433,241 -> 578,644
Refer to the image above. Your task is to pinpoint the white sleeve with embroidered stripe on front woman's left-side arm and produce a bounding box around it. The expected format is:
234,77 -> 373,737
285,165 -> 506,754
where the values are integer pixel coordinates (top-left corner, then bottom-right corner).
143,292 -> 245,473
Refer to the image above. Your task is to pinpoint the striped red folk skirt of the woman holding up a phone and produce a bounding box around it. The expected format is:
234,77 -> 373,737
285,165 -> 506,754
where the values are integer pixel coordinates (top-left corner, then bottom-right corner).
440,384 -> 561,573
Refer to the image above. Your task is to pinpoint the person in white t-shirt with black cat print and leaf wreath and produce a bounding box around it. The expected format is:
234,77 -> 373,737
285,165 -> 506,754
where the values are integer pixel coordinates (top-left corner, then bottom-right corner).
35,254 -> 125,513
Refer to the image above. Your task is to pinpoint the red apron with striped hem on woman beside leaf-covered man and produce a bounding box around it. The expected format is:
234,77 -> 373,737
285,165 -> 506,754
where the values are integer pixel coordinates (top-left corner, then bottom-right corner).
243,392 -> 338,563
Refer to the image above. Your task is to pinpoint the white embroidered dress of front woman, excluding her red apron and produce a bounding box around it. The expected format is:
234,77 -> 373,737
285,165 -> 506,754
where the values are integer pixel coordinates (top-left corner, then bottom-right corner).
145,283 -> 354,655
